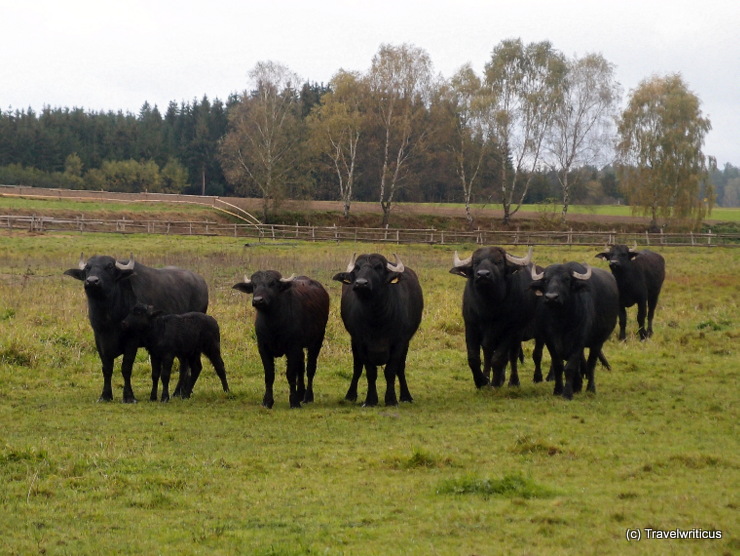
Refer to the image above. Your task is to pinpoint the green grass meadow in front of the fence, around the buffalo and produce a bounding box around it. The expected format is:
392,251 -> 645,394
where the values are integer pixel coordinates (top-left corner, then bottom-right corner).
0,232 -> 740,555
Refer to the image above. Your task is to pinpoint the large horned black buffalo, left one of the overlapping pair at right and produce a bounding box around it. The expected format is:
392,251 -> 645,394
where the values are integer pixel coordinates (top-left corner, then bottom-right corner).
450,247 -> 543,388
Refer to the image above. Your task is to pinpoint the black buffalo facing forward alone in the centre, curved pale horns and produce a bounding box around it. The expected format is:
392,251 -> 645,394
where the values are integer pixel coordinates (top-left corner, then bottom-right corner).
334,253 -> 424,406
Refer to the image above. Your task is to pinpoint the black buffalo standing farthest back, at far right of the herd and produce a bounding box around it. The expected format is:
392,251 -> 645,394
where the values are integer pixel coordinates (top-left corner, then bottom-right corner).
596,245 -> 665,340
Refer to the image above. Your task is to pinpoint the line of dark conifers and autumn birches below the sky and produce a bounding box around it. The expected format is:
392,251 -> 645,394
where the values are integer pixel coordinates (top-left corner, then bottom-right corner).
0,39 -> 740,225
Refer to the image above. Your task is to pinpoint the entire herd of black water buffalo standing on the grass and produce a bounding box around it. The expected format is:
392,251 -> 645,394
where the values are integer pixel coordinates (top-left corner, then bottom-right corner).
64,245 -> 665,408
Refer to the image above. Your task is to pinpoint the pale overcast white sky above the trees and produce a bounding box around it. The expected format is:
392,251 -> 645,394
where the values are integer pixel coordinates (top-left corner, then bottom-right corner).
0,0 -> 740,166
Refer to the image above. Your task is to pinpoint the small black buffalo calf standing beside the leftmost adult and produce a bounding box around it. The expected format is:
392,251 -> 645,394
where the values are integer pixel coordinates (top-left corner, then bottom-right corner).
121,303 -> 229,402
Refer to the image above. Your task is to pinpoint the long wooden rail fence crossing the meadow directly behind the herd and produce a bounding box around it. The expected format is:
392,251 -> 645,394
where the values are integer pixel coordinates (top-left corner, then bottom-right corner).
0,215 -> 740,247
